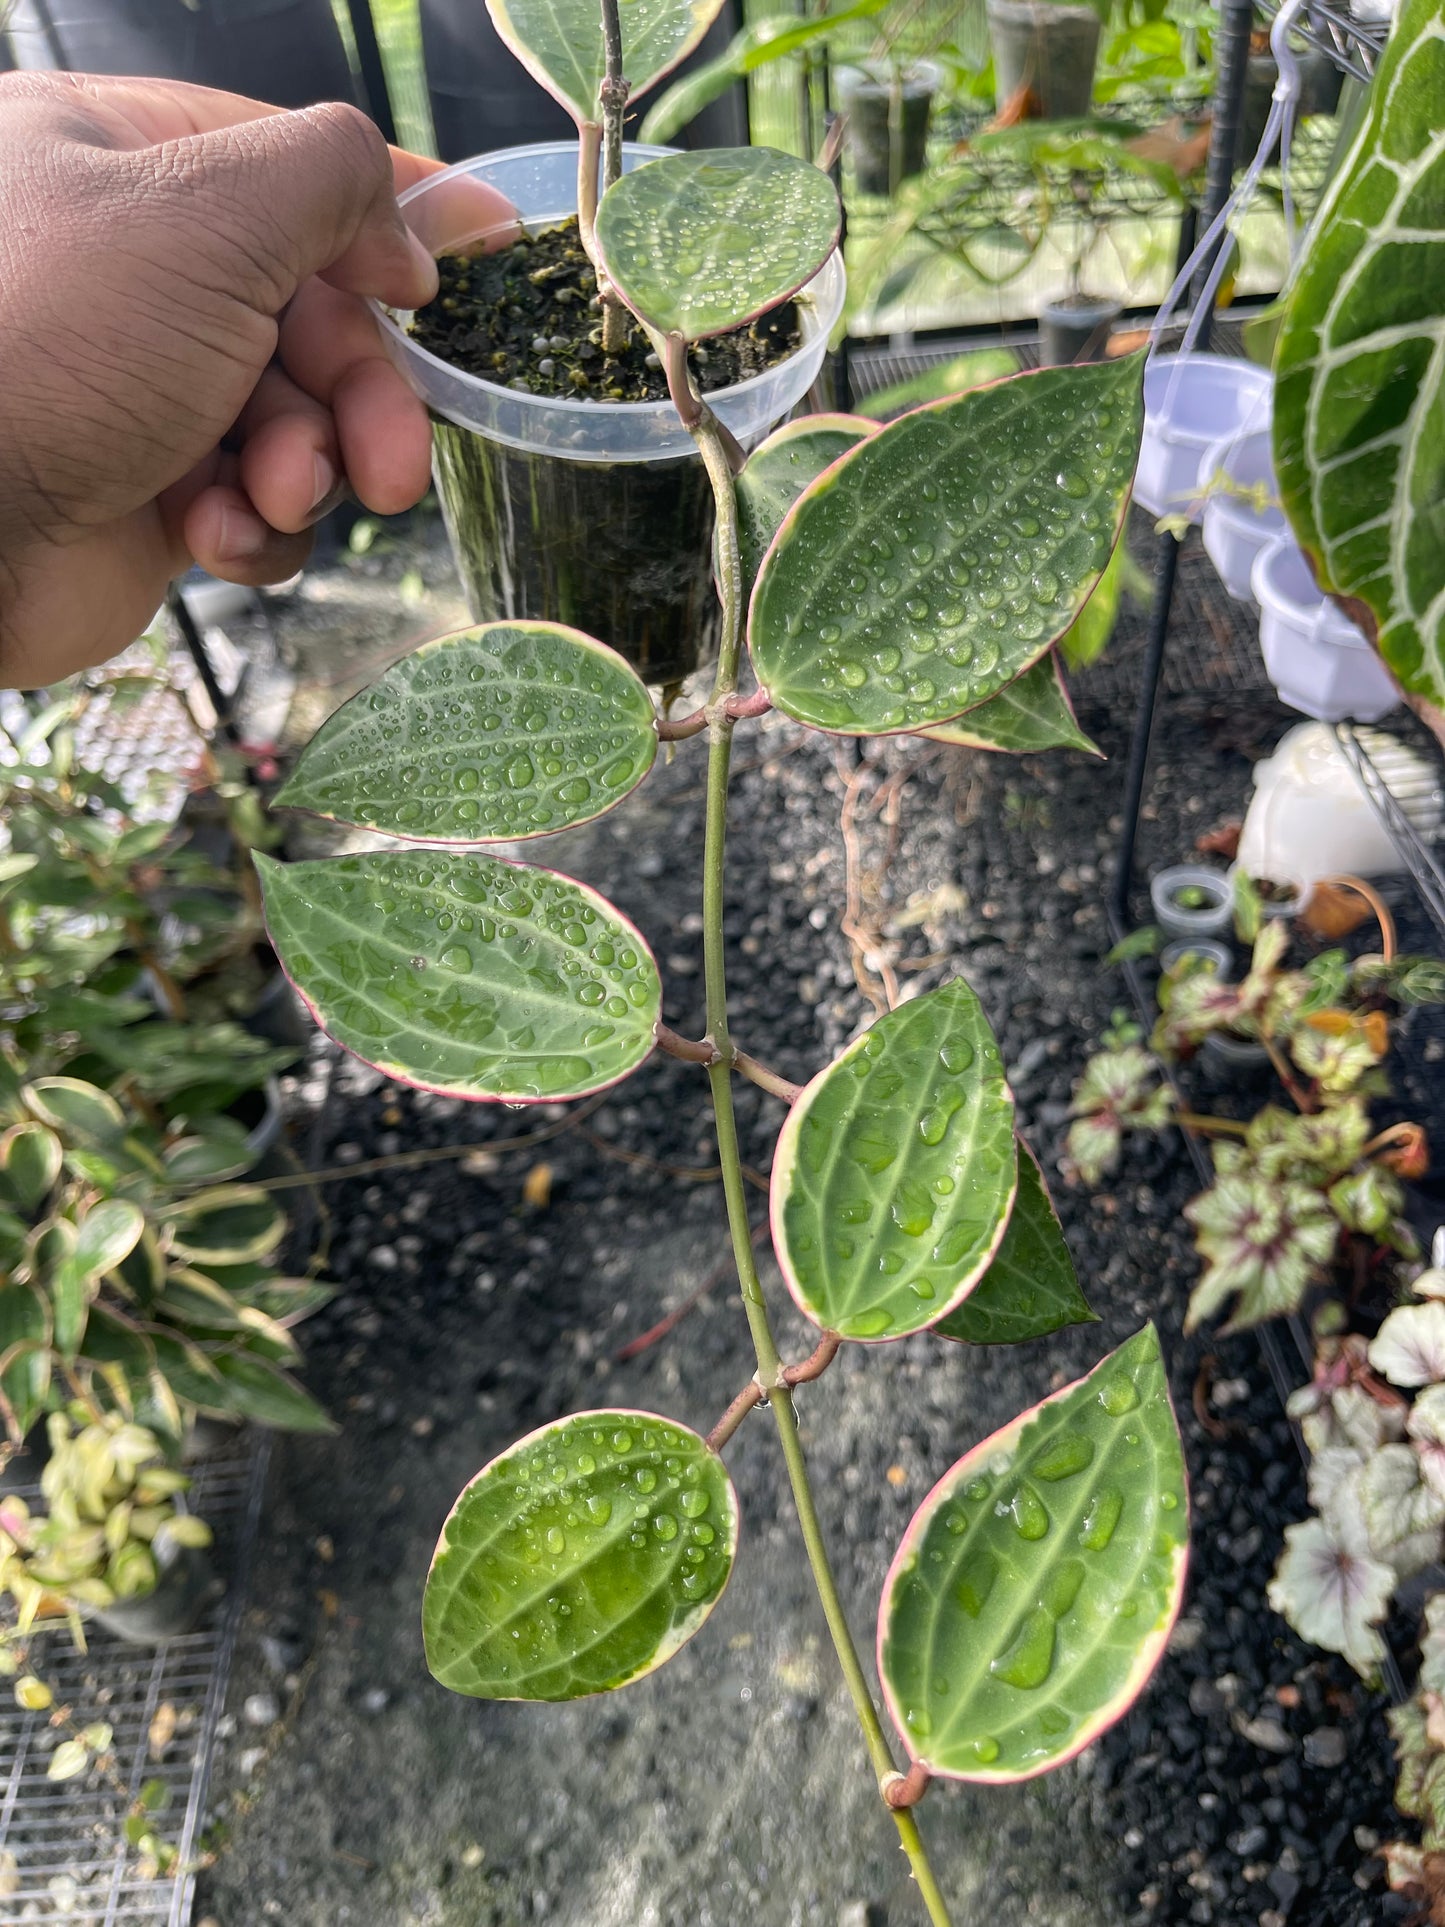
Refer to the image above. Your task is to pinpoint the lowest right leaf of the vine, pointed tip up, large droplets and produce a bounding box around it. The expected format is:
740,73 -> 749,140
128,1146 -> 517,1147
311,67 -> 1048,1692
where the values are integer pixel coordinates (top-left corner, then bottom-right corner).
879,1326 -> 1189,1781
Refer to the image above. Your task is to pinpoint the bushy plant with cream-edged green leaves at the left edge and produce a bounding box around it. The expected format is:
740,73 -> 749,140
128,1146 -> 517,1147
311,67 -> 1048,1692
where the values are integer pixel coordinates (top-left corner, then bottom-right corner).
0,1062 -> 329,1451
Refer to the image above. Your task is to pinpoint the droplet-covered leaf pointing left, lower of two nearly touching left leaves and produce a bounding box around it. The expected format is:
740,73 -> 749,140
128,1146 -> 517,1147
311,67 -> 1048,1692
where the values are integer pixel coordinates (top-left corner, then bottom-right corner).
256,850 -> 663,1102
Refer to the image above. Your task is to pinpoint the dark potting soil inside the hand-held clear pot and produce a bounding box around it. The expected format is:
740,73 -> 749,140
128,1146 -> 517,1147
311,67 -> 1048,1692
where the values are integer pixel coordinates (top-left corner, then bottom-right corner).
410,220 -> 800,401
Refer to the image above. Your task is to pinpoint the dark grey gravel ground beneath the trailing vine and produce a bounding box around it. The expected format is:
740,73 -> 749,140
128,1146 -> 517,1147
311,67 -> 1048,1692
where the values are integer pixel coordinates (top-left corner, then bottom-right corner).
186,520 -> 1405,1927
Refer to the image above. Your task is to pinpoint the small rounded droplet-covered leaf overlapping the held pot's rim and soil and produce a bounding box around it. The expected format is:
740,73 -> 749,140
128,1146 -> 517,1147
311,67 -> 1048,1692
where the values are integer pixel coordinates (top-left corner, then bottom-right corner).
597,146 -> 840,341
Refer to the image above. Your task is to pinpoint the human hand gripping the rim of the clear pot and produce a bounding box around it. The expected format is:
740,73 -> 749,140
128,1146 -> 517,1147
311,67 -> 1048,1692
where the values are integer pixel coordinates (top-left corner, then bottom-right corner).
0,73 -> 511,688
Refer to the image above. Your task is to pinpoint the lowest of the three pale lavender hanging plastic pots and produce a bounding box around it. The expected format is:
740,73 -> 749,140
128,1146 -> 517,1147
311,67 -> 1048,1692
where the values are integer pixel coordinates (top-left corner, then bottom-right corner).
1252,536 -> 1401,723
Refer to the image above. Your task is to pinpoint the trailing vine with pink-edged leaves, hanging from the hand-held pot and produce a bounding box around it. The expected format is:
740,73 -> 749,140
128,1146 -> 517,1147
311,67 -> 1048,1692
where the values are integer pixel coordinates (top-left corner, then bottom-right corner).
258,0 -> 1187,1923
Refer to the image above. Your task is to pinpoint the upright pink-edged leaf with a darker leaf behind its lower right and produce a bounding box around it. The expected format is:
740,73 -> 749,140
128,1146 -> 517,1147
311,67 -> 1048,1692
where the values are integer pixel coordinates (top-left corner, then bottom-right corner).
771,979 -> 1017,1341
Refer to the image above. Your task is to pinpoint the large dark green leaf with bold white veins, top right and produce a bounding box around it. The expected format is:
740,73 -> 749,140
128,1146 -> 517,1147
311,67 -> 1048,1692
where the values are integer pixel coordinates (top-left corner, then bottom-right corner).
1274,0 -> 1445,701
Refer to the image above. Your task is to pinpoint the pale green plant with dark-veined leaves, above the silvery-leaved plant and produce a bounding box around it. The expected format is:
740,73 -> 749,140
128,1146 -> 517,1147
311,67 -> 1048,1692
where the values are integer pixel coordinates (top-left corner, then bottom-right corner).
1069,919 -> 1445,1330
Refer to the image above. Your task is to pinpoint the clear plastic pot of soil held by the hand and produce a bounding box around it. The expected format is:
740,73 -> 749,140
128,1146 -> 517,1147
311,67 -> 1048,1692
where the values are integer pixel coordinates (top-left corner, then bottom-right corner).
378,141 -> 844,682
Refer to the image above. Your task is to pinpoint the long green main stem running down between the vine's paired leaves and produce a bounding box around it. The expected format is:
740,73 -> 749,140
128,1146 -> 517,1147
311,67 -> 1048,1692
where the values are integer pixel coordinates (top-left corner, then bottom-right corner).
688,409 -> 950,1927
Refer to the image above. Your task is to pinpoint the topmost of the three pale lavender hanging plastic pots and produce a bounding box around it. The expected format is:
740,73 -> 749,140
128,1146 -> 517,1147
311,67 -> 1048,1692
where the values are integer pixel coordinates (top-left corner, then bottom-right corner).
1135,355 -> 1274,520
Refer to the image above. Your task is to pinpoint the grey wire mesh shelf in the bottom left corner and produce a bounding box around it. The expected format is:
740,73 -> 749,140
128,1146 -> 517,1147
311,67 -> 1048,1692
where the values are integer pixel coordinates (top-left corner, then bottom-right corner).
0,1432 -> 270,1927
